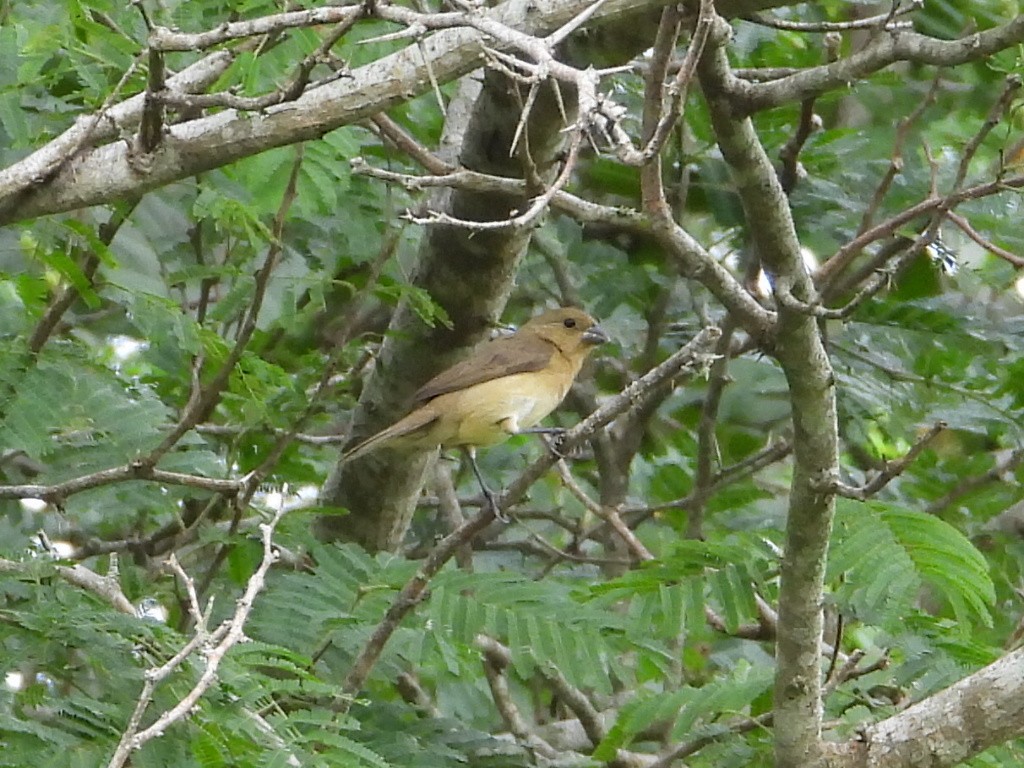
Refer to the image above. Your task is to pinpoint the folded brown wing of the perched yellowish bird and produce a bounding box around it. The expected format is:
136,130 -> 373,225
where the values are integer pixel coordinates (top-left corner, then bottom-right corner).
414,334 -> 555,402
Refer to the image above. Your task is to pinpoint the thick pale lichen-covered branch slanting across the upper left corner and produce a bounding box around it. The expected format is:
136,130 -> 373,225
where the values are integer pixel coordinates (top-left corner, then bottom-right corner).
0,0 -> 659,224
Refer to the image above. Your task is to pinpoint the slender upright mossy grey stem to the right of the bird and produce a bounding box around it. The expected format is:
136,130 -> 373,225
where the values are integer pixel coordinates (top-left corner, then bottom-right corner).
698,13 -> 839,767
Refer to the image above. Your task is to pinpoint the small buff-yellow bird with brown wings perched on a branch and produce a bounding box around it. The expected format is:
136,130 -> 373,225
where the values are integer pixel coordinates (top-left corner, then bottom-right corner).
342,307 -> 609,517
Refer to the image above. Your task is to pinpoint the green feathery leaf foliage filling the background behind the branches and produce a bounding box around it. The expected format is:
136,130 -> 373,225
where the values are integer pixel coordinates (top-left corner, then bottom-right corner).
0,0 -> 1024,768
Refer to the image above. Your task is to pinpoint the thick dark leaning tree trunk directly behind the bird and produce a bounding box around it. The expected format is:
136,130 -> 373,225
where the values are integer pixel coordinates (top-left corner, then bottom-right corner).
317,73 -> 574,551
